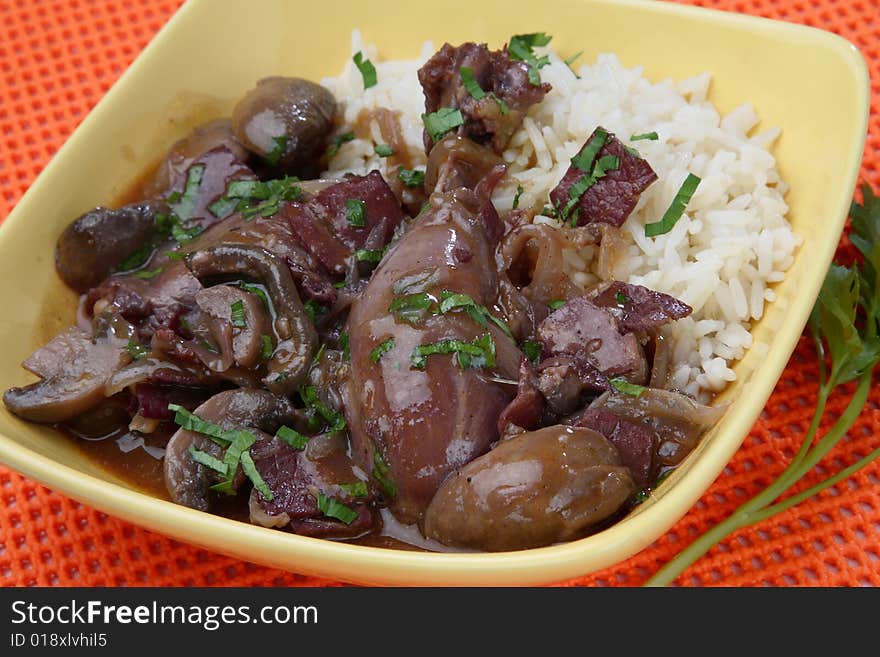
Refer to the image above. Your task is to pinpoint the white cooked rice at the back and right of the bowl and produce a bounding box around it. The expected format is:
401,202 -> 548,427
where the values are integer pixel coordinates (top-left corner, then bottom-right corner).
322,31 -> 801,400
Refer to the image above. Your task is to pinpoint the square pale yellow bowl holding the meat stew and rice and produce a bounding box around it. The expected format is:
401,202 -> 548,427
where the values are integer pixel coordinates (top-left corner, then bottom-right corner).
0,0 -> 868,585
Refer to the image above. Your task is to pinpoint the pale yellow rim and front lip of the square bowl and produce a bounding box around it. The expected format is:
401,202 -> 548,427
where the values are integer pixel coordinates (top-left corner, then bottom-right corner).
0,0 -> 870,586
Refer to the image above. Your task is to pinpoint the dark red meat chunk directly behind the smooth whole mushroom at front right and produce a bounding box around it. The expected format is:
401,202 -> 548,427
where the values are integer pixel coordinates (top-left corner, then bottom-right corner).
571,408 -> 658,489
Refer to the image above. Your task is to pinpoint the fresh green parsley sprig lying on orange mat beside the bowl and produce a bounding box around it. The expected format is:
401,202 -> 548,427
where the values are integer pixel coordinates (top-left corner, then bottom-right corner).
646,185 -> 880,586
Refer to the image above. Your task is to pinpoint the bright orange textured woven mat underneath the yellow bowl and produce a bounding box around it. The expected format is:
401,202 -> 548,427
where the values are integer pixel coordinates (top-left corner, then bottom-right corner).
0,0 -> 880,586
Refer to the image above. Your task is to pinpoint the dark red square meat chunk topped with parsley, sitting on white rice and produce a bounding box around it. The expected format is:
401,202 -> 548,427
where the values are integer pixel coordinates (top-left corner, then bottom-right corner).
550,128 -> 657,226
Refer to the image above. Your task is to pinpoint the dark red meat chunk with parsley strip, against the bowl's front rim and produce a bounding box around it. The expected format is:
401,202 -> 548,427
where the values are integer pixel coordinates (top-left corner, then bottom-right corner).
249,435 -> 377,538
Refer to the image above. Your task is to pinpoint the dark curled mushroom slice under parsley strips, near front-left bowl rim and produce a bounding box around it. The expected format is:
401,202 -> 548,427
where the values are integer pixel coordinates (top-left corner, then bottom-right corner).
164,389 -> 302,511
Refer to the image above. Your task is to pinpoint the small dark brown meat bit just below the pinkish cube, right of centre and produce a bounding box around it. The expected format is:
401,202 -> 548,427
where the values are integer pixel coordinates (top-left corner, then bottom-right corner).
536,355 -> 611,415
